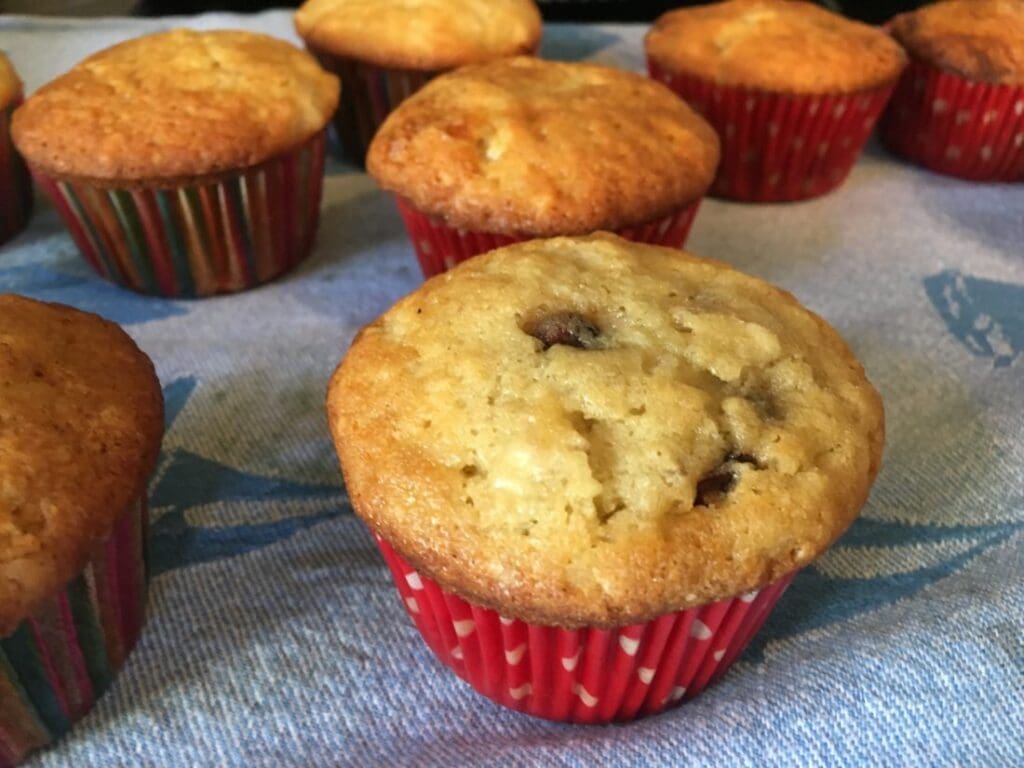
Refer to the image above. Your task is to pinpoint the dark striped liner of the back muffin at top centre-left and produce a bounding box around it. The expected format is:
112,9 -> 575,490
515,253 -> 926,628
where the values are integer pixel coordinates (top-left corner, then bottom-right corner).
310,48 -> 442,165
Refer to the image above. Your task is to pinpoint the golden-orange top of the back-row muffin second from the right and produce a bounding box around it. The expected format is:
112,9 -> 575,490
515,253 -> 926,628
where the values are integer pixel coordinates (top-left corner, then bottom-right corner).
645,0 -> 906,93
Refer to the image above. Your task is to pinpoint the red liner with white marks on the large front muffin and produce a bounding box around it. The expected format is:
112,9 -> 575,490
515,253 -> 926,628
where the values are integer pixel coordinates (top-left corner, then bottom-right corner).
376,537 -> 796,723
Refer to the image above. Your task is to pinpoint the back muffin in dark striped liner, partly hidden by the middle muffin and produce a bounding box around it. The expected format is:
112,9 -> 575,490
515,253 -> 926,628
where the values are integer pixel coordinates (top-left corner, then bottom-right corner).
295,0 -> 541,164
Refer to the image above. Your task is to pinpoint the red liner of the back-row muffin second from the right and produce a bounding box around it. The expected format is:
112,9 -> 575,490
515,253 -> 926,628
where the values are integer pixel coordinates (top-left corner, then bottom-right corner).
647,58 -> 894,203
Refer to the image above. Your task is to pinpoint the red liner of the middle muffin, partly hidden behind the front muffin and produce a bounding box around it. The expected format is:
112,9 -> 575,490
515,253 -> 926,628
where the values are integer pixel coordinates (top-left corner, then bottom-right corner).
395,196 -> 700,278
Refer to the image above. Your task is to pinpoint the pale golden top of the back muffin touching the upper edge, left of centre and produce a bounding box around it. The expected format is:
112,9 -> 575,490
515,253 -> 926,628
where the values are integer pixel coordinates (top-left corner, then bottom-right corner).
295,0 -> 541,70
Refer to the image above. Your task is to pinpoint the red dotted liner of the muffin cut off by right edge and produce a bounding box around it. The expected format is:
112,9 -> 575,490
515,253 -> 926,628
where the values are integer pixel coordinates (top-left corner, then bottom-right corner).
881,59 -> 1024,181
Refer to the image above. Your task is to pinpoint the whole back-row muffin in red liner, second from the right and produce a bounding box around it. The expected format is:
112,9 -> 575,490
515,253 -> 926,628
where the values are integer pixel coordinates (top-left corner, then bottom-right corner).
645,0 -> 906,203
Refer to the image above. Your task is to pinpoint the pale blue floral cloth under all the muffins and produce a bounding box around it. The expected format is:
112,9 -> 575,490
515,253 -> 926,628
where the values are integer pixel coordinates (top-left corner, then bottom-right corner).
0,12 -> 1024,768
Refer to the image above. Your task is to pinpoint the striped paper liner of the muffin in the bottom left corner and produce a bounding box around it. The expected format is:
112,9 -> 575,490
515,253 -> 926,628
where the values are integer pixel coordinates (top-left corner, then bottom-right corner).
0,499 -> 147,768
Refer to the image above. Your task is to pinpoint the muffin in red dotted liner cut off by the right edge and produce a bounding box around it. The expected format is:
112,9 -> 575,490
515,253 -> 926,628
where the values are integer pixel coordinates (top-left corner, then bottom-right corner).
882,0 -> 1024,181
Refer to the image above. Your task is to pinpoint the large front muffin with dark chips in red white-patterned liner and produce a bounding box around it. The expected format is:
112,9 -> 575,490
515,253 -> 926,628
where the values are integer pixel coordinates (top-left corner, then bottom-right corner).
328,233 -> 884,722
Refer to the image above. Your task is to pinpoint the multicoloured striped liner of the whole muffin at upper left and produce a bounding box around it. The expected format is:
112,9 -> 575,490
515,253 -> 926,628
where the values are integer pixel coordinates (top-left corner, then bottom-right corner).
32,131 -> 326,298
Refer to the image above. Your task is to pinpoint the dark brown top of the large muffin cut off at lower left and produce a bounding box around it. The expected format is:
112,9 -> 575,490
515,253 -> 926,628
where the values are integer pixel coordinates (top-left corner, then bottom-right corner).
0,294 -> 163,637
